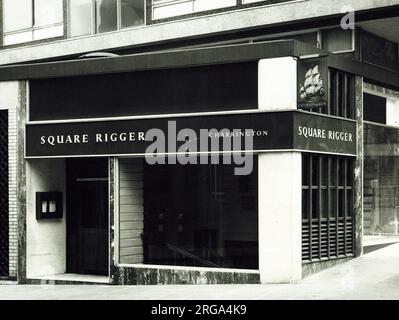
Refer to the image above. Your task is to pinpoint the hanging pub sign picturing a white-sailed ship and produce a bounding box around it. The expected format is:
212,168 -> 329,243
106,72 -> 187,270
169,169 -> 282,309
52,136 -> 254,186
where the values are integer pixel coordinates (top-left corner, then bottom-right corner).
298,58 -> 328,110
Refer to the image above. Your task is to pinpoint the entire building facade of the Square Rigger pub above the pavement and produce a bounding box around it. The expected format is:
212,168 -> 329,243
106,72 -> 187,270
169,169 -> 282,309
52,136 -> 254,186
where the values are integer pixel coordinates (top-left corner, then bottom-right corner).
0,0 -> 399,285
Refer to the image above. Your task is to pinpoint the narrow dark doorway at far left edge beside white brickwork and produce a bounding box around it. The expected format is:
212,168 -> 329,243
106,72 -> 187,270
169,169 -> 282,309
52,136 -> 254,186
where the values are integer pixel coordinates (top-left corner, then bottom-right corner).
0,111 -> 9,277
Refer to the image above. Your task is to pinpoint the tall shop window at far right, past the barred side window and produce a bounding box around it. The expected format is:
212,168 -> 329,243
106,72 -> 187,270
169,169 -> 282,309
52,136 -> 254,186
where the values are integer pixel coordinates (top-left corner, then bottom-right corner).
363,87 -> 399,242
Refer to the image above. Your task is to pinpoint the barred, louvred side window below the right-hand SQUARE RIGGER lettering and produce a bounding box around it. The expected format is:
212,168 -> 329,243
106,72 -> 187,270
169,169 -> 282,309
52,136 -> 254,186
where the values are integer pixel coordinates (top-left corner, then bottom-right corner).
302,154 -> 354,263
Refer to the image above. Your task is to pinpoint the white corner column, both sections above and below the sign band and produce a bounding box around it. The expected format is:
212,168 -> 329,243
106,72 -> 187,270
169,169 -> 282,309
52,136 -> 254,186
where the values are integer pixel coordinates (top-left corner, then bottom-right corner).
258,57 -> 302,283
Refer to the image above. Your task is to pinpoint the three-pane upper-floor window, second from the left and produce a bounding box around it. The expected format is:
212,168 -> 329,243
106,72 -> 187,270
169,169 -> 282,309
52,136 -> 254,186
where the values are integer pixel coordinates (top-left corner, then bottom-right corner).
69,0 -> 145,37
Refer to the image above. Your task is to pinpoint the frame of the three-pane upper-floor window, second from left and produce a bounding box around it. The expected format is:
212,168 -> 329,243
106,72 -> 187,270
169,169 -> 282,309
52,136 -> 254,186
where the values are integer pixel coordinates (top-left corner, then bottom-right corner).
68,0 -> 147,39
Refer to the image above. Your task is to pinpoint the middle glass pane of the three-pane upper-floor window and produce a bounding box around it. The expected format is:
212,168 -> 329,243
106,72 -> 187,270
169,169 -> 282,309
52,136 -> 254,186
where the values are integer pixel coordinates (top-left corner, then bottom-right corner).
96,0 -> 118,33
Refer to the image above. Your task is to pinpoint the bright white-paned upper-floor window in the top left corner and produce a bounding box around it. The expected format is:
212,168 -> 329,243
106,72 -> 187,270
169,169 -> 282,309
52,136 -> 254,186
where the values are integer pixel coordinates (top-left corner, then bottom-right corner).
3,0 -> 64,45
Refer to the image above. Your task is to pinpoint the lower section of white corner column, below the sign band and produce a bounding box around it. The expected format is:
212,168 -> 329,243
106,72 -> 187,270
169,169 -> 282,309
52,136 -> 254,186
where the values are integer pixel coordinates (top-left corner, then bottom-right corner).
258,152 -> 302,283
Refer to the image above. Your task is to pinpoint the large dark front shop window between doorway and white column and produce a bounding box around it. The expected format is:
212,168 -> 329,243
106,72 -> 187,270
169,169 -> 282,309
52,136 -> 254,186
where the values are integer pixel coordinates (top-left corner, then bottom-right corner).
119,158 -> 258,269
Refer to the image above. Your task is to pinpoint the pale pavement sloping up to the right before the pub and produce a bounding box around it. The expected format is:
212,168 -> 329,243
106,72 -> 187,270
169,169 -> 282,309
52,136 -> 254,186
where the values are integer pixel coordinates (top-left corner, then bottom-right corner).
0,243 -> 399,300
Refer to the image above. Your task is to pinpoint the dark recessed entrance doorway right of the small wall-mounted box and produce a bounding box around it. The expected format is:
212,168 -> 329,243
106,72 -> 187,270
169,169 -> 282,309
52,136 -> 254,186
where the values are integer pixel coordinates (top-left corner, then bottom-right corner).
67,158 -> 109,275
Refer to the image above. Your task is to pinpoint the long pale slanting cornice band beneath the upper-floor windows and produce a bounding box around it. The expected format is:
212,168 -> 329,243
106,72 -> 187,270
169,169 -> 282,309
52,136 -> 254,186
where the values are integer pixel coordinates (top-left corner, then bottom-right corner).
0,0 -> 399,65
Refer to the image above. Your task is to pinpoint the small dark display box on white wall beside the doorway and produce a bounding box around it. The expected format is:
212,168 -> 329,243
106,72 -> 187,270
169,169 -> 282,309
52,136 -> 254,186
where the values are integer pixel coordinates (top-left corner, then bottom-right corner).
36,192 -> 63,220
